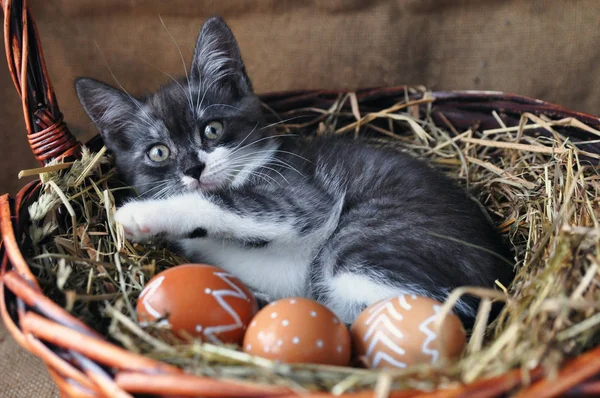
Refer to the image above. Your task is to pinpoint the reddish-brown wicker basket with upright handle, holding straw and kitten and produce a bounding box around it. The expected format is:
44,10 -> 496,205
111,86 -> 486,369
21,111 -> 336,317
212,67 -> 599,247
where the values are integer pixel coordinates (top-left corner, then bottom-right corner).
0,0 -> 600,398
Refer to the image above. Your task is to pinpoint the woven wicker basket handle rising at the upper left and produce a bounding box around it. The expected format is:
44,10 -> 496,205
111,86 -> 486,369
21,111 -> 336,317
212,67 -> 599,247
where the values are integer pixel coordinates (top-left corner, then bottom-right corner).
0,0 -> 80,164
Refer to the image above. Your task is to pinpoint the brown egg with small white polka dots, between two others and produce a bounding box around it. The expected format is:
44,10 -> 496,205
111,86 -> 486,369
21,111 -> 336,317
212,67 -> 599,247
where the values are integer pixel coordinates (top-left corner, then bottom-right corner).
243,297 -> 351,366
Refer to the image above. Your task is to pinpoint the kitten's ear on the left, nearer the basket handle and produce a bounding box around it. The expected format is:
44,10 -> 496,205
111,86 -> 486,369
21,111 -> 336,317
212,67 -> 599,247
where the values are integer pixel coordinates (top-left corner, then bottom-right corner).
75,78 -> 136,136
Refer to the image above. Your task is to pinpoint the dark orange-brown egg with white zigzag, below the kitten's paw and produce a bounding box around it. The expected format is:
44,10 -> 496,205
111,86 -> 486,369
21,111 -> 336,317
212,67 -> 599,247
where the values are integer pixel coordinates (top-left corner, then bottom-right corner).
137,264 -> 258,344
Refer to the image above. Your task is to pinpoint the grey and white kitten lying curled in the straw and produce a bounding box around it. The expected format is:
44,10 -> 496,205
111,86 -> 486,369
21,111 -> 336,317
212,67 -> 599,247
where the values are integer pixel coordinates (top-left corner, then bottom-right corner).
76,18 -> 513,324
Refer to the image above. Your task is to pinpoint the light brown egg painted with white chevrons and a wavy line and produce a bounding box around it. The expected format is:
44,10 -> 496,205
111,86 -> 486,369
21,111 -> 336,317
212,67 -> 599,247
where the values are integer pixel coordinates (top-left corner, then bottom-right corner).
350,294 -> 466,369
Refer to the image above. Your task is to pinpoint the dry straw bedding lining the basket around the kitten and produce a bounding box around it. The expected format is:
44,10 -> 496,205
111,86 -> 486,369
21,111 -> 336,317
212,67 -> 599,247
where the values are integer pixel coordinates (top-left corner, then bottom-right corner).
25,88 -> 600,393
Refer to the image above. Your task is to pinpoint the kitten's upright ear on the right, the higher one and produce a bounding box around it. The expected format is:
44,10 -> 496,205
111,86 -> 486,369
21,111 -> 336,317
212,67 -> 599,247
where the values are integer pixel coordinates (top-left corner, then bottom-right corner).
191,17 -> 252,95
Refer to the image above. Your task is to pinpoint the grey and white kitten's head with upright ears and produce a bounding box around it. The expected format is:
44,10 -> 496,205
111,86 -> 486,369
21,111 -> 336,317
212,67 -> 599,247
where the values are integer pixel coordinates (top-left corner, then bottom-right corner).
76,17 -> 275,197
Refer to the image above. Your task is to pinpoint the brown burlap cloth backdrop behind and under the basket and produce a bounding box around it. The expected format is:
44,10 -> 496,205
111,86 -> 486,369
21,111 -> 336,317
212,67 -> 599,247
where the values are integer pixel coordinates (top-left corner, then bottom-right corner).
0,0 -> 600,397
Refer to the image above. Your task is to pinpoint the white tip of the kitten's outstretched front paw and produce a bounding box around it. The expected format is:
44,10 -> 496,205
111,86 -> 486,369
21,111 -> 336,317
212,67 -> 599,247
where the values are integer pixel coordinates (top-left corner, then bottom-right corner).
115,202 -> 161,242
